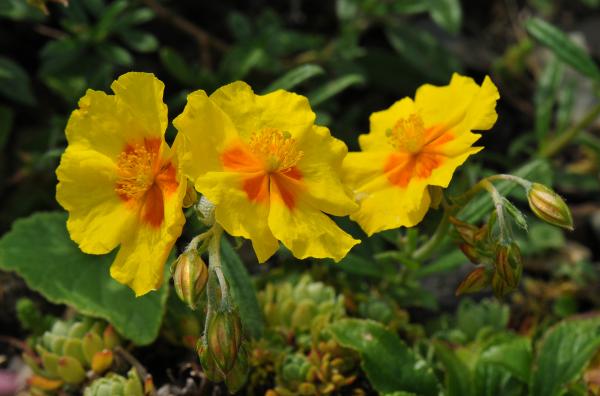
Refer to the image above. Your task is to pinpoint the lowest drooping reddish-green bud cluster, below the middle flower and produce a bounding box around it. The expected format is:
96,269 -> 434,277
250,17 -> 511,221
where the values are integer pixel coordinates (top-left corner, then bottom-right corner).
197,310 -> 248,393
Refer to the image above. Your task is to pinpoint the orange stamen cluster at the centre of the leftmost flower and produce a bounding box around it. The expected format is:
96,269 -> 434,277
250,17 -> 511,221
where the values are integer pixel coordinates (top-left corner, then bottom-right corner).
115,142 -> 160,201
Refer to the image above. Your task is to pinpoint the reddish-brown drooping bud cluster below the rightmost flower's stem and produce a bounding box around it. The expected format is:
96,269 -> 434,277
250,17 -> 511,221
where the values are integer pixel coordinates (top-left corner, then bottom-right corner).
450,216 -> 523,298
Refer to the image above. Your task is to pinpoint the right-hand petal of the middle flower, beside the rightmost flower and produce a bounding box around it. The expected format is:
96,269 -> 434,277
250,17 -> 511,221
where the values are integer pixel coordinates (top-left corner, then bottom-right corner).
298,126 -> 358,216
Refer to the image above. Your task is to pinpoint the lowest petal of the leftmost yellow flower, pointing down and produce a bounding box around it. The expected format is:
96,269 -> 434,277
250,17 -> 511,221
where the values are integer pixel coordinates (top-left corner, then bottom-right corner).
110,170 -> 187,297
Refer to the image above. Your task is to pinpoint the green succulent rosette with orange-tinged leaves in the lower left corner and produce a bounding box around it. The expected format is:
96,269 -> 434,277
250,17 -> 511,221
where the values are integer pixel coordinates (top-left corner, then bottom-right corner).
23,318 -> 121,395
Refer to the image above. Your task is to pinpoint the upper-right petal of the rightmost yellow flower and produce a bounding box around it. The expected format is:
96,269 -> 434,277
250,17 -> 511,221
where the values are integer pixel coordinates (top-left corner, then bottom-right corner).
415,73 -> 500,135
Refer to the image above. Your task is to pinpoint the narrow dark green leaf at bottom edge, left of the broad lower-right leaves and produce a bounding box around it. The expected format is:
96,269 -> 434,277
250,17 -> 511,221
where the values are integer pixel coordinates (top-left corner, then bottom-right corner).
433,342 -> 474,396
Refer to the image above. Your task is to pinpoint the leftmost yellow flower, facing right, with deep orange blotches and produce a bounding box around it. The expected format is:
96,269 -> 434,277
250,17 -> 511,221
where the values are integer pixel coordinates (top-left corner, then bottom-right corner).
56,73 -> 186,296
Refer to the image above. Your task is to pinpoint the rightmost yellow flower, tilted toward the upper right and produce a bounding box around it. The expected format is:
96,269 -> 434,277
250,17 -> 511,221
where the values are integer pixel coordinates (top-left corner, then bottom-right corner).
343,74 -> 500,235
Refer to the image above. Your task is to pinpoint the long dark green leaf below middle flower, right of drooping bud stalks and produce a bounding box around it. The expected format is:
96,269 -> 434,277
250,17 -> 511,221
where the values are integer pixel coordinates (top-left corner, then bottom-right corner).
221,238 -> 264,339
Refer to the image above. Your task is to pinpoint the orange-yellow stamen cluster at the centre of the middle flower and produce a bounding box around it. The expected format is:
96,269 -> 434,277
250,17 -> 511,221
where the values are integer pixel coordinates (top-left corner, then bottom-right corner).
248,128 -> 304,173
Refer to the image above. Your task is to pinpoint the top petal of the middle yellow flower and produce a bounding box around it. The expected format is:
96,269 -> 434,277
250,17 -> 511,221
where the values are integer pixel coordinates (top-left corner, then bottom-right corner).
210,81 -> 315,139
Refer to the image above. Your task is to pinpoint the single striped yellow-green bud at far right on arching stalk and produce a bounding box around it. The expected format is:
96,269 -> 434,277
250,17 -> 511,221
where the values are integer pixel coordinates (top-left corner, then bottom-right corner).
527,183 -> 573,231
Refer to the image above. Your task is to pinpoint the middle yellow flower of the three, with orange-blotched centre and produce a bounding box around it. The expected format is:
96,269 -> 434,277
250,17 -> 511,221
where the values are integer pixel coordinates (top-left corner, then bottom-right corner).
173,81 -> 358,262
